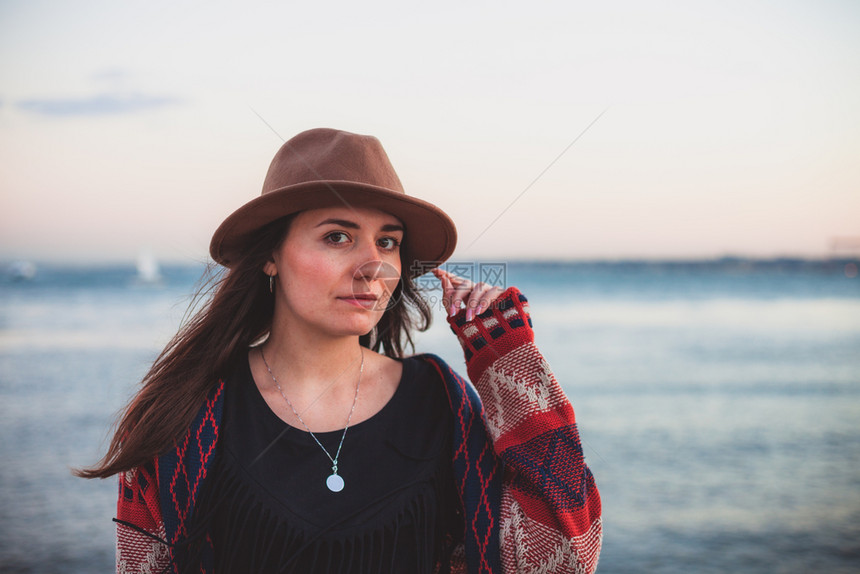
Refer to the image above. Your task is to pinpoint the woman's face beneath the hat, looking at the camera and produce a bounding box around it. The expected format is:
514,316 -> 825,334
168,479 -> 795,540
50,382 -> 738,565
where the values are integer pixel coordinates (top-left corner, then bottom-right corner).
264,207 -> 403,337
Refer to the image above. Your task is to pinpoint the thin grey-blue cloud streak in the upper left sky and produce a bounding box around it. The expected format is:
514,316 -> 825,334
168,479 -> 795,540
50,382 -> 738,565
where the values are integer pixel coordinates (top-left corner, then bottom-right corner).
17,93 -> 182,117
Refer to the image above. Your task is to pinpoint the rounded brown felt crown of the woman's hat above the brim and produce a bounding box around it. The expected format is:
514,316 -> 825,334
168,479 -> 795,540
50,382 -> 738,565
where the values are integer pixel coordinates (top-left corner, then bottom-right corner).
262,128 -> 405,195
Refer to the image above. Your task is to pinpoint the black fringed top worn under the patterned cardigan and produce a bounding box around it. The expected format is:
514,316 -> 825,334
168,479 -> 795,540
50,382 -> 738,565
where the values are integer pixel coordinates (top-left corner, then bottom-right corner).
181,358 -> 462,574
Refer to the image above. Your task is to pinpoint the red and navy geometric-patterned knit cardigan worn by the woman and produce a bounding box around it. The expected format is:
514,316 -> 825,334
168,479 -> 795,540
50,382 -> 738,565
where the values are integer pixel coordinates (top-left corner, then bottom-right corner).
117,288 -> 602,574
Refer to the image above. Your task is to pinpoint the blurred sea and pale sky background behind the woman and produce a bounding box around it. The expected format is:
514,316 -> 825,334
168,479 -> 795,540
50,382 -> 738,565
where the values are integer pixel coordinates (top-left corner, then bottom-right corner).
0,0 -> 860,573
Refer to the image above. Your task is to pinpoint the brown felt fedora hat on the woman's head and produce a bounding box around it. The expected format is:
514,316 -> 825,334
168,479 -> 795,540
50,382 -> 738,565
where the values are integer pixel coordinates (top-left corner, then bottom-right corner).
209,128 -> 457,276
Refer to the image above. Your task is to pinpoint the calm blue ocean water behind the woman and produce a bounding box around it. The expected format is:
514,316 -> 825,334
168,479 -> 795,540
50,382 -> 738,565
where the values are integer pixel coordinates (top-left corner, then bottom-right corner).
0,260 -> 860,574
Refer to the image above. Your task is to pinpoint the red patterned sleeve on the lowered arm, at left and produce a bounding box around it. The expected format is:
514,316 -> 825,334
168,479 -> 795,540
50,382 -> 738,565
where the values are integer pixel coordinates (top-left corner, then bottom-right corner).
116,462 -> 170,574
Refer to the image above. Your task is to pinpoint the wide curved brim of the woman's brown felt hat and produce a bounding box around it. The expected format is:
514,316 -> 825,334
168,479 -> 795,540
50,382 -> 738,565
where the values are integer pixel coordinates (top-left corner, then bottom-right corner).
209,181 -> 457,277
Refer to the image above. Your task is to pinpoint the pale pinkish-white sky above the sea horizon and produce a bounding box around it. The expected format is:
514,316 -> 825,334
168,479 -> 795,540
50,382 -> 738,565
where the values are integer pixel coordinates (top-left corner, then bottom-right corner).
0,0 -> 860,262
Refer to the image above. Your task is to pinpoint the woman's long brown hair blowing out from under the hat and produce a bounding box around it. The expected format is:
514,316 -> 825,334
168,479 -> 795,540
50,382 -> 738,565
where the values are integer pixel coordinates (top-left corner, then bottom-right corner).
74,216 -> 432,478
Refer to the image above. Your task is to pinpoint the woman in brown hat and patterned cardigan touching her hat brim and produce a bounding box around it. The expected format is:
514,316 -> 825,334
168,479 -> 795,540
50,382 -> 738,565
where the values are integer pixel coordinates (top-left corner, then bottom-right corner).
80,129 -> 601,574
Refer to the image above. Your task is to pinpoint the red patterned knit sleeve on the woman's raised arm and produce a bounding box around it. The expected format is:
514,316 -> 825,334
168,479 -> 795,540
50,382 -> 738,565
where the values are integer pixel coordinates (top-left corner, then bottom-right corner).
448,287 -> 602,574
